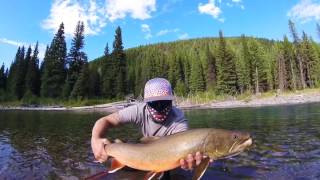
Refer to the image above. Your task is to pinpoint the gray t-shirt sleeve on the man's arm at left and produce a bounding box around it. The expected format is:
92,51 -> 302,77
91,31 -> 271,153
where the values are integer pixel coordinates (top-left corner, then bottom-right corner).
118,105 -> 140,124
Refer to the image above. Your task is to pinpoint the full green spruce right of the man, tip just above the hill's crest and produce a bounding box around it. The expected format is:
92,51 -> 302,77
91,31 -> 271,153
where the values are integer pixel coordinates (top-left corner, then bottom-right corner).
217,31 -> 237,94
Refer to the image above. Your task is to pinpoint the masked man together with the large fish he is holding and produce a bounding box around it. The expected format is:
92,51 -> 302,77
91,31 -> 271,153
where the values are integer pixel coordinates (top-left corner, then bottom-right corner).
91,78 -> 252,180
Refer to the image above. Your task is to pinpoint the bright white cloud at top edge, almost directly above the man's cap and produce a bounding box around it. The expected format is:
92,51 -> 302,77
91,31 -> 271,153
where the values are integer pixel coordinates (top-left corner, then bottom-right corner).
106,0 -> 156,21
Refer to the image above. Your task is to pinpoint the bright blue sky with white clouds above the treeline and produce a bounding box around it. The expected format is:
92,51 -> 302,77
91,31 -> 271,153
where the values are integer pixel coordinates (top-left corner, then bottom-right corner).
0,0 -> 320,67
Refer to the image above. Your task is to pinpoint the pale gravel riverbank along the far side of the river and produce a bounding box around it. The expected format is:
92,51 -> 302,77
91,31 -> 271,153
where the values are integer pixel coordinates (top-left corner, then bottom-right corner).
0,89 -> 320,112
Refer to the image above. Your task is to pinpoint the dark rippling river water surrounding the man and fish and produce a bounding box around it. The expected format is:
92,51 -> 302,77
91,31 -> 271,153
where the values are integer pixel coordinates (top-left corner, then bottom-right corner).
0,103 -> 320,179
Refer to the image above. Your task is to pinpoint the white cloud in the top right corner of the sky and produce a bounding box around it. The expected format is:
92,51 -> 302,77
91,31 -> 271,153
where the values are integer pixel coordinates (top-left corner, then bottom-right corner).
287,0 -> 320,23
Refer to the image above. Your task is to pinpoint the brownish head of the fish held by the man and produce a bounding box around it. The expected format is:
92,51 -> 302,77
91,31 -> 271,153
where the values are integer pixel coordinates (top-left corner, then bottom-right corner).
205,130 -> 252,159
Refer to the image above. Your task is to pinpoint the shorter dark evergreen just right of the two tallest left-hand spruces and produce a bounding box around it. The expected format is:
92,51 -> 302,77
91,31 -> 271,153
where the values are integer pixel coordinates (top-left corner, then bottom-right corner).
71,61 -> 89,99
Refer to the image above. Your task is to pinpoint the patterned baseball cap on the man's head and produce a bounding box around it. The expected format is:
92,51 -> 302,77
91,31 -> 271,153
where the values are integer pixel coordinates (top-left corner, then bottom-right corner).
144,78 -> 174,102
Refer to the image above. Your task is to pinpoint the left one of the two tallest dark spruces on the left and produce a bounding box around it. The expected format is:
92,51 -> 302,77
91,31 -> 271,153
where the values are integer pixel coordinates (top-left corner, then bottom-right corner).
41,23 -> 67,98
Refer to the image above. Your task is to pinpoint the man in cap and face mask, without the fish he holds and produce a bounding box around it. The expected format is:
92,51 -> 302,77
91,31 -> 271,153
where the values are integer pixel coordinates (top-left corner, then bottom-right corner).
91,78 -> 203,170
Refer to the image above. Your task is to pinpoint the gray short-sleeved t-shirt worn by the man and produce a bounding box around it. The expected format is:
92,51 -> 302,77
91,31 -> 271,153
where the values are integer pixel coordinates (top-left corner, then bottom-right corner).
118,103 -> 188,137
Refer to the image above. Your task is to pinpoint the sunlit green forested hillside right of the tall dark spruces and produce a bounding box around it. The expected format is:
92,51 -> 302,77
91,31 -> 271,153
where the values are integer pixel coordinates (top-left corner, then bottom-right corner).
91,21 -> 320,99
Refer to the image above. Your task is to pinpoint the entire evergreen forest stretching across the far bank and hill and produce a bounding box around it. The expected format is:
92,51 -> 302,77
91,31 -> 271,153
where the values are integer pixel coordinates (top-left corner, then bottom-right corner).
0,20 -> 320,104
